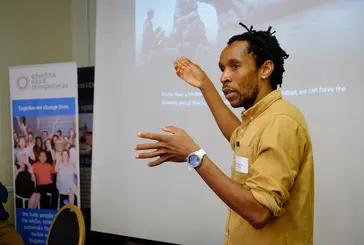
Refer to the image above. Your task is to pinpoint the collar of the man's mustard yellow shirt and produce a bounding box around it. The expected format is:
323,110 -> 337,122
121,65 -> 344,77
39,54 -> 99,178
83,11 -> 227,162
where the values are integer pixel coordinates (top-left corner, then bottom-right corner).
241,90 -> 282,126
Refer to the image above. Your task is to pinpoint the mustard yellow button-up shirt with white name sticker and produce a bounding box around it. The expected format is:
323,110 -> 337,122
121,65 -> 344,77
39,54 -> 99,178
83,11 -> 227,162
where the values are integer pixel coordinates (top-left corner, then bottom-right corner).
225,90 -> 314,245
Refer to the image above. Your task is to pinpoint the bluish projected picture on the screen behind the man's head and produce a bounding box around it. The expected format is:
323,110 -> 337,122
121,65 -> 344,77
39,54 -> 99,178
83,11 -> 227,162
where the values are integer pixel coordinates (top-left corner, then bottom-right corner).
135,0 -> 354,107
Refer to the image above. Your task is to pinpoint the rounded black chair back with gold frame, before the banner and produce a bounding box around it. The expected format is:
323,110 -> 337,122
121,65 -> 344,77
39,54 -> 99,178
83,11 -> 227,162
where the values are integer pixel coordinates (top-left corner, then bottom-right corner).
46,204 -> 86,245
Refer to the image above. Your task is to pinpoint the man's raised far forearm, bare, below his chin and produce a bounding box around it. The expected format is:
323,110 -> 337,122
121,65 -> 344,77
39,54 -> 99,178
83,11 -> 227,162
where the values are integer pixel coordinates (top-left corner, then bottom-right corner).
200,80 -> 241,141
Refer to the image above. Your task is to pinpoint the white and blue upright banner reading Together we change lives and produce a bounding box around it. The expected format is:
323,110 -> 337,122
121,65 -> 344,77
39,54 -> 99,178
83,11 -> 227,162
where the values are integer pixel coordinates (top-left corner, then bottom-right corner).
9,62 -> 80,245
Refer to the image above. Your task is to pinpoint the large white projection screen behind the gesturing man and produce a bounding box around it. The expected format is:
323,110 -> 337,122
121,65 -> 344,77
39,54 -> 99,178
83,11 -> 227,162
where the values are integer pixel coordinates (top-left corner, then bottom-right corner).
91,0 -> 364,245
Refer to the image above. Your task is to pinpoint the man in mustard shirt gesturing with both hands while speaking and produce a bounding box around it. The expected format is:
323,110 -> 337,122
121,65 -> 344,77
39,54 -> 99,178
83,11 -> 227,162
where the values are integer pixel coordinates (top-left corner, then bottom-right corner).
135,23 -> 314,245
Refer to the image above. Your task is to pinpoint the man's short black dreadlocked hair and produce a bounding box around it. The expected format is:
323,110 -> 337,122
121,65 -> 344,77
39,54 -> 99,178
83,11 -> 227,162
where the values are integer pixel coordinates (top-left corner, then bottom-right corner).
228,22 -> 289,89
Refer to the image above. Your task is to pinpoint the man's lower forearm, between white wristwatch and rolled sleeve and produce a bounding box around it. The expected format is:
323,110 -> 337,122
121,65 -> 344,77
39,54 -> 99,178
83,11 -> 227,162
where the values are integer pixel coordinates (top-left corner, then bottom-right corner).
196,157 -> 271,229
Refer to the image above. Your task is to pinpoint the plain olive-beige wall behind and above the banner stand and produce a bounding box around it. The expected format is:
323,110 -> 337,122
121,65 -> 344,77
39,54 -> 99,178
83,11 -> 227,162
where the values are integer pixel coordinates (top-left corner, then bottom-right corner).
0,0 -> 73,221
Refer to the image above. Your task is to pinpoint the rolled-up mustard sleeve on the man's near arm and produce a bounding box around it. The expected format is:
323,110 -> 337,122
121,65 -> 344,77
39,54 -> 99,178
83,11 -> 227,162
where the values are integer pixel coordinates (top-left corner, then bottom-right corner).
246,115 -> 307,216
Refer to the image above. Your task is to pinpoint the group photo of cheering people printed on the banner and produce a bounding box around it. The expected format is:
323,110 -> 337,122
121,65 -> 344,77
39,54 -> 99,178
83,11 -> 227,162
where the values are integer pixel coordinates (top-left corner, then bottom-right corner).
13,116 -> 79,210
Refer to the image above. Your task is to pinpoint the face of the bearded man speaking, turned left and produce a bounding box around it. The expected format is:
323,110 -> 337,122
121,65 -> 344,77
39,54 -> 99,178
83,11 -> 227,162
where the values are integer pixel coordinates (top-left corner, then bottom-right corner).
219,41 -> 259,109
